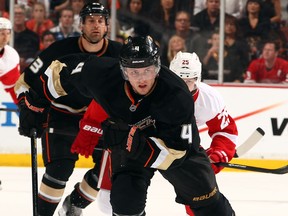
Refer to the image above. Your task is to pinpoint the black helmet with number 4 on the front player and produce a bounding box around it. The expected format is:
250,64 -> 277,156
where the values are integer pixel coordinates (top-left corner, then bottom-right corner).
120,36 -> 160,68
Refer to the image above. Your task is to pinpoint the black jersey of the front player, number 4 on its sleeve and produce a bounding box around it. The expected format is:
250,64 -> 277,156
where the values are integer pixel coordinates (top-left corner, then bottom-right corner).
47,55 -> 200,168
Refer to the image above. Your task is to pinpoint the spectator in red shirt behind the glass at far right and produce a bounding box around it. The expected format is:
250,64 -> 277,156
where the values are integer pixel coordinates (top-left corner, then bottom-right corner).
244,41 -> 288,84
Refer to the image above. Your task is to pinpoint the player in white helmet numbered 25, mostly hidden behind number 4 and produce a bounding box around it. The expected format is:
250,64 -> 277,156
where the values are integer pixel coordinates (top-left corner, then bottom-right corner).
169,51 -> 238,216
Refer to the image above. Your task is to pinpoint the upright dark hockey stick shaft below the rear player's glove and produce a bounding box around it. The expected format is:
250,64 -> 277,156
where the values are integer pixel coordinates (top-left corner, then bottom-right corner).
30,128 -> 38,216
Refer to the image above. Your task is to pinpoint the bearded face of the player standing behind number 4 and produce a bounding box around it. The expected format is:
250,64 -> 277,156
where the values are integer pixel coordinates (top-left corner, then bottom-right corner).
82,15 -> 108,43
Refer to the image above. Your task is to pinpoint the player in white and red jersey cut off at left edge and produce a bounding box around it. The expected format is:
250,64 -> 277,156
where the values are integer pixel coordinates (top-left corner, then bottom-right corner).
0,17 -> 20,104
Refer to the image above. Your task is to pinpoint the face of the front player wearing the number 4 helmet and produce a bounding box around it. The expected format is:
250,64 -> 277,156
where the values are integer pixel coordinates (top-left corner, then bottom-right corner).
125,65 -> 157,95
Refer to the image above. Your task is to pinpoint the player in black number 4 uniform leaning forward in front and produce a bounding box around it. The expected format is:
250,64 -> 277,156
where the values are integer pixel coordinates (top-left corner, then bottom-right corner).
41,36 -> 235,216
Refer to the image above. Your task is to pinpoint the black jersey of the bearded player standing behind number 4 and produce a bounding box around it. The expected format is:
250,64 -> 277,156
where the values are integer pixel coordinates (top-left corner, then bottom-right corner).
16,37 -> 122,114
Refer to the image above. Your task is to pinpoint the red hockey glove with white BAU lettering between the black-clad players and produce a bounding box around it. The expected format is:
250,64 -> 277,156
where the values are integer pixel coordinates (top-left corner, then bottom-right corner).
71,119 -> 103,158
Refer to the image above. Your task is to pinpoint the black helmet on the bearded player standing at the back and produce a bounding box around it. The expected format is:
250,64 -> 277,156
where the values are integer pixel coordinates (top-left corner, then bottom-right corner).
79,2 -> 109,25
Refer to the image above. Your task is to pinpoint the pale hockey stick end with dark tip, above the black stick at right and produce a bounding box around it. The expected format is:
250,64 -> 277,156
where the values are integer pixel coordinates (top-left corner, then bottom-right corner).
234,127 -> 265,158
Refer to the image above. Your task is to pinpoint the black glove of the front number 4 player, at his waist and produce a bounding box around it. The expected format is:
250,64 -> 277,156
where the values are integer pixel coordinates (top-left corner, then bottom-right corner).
101,118 -> 130,149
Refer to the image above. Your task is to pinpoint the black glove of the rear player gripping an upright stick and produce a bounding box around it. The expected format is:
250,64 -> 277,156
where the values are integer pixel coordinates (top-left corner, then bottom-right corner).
18,89 -> 50,138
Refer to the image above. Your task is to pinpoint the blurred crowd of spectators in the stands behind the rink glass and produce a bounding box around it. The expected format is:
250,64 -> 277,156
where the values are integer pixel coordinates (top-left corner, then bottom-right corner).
0,0 -> 288,83
